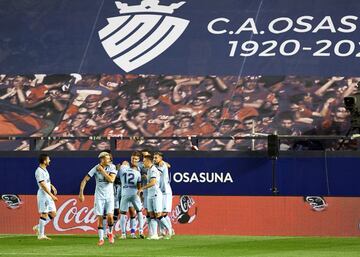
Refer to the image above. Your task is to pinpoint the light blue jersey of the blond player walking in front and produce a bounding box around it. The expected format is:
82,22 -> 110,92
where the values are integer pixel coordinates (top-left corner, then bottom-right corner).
88,164 -> 117,199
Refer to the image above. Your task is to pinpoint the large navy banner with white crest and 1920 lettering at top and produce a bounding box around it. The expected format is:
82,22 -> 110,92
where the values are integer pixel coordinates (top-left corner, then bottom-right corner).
0,0 -> 360,75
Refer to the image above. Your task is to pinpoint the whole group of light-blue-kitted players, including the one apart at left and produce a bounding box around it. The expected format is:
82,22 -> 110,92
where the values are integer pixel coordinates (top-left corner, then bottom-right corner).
33,150 -> 174,246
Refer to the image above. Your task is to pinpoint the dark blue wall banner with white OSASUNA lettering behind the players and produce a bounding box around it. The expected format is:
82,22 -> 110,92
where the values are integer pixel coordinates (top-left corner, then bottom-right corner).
0,154 -> 360,196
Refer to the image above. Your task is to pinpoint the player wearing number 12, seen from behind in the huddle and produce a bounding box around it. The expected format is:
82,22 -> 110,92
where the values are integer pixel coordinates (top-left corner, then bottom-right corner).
119,151 -> 144,239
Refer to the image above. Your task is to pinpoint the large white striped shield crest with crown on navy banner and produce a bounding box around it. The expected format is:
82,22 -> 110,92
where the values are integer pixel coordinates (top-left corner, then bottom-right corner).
99,0 -> 190,72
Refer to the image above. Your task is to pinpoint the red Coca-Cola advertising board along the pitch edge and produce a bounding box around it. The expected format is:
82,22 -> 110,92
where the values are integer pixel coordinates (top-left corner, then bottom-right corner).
0,195 -> 360,236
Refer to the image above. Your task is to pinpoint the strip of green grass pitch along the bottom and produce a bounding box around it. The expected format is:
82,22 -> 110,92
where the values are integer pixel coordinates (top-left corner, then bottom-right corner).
0,235 -> 360,257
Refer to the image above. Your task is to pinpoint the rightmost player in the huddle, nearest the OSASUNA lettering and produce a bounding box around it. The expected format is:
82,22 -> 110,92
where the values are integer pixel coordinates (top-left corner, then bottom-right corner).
154,152 -> 173,237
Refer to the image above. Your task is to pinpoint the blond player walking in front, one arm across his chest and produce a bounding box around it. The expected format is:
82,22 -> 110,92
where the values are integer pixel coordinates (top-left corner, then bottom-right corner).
79,152 -> 117,246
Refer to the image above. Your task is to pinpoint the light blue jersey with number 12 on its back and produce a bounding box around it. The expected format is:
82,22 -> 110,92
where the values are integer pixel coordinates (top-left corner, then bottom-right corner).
119,166 -> 141,196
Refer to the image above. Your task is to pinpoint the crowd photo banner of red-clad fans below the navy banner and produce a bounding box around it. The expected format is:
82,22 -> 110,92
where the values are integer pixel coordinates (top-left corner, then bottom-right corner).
0,73 -> 354,151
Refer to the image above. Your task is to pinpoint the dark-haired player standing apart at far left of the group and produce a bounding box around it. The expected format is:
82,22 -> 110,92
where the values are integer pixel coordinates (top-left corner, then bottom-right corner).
33,154 -> 58,240
